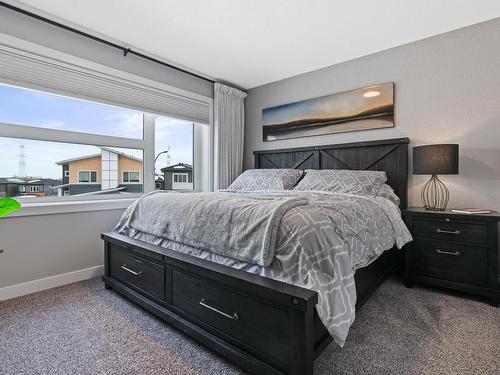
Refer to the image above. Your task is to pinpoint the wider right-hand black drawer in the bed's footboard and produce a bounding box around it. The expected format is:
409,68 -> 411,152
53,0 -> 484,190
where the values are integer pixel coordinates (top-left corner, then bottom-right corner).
172,270 -> 289,361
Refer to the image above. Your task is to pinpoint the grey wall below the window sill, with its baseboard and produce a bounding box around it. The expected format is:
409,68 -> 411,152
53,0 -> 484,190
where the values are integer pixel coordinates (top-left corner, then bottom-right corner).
0,209 -> 123,300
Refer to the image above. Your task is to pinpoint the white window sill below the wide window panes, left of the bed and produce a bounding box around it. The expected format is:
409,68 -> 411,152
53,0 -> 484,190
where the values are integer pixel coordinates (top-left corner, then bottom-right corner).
3,197 -> 137,219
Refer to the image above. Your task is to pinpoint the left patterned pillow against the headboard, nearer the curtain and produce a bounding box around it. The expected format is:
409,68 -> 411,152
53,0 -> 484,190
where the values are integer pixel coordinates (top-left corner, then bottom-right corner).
228,169 -> 303,191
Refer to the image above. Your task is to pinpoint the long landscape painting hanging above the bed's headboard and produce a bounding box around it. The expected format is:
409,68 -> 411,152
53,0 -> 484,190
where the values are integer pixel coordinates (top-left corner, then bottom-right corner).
262,82 -> 394,141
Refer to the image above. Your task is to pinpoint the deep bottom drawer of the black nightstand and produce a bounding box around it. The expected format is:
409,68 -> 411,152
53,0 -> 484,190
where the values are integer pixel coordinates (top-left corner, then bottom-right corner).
412,240 -> 488,286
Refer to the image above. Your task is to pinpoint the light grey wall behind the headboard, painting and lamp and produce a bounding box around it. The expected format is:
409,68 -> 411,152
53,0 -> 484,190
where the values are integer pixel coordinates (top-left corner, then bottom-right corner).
245,18 -> 500,210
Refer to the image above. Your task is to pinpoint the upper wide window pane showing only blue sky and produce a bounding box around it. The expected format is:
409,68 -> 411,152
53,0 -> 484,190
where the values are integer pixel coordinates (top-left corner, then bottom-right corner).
0,84 -> 143,139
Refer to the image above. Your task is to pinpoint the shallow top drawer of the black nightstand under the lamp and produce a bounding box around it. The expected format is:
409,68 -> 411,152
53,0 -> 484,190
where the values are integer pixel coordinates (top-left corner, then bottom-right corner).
413,219 -> 488,245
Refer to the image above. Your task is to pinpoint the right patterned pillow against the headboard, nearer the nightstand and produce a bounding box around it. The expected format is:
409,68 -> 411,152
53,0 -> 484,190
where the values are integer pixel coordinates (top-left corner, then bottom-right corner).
294,169 -> 387,196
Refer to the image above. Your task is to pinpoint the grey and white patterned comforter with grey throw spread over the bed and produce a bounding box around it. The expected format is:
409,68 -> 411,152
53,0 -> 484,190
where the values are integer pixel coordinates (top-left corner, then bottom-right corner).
115,190 -> 411,346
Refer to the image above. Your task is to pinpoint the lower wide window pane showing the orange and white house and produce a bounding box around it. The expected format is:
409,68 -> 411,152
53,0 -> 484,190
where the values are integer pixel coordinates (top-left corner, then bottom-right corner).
0,137 -> 143,198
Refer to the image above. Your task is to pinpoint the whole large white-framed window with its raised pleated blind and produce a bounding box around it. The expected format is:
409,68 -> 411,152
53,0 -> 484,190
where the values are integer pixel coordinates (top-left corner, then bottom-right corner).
0,36 -> 213,206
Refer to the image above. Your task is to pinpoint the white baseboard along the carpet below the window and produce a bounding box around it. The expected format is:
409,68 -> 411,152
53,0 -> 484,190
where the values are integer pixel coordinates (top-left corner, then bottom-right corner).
0,265 -> 104,301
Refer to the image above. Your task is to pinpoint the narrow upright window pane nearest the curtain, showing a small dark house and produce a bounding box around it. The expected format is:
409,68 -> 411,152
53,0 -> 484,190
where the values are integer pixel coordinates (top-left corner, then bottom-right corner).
155,116 -> 194,190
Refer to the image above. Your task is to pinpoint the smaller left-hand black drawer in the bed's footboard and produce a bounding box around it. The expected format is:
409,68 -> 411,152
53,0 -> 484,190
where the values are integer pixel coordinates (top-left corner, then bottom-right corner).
108,245 -> 165,300
